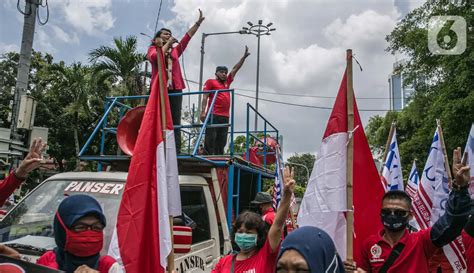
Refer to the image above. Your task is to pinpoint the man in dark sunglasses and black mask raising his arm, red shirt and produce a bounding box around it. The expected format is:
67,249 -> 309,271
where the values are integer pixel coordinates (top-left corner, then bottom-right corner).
346,148 -> 471,273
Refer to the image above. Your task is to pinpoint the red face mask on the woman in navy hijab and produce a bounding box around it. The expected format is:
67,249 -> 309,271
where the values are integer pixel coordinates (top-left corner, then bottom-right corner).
56,210 -> 104,257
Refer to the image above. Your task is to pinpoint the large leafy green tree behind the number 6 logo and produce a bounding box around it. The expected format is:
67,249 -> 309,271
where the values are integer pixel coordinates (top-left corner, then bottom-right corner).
367,0 -> 474,177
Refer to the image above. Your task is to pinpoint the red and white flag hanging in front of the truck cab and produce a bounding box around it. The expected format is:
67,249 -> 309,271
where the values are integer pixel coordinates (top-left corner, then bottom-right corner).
109,46 -> 181,273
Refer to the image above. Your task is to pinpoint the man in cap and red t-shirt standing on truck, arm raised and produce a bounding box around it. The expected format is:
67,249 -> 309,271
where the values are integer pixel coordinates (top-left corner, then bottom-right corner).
200,46 -> 250,155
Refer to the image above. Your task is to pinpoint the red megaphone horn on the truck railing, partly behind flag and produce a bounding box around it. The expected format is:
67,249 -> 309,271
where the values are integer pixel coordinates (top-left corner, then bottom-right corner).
117,106 -> 146,156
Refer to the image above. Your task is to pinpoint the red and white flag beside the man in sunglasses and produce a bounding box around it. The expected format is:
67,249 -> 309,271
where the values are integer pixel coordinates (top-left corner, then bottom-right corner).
298,69 -> 384,263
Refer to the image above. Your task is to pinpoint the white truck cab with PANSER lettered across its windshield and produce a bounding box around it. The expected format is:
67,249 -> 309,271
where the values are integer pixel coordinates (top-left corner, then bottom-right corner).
0,169 -> 232,273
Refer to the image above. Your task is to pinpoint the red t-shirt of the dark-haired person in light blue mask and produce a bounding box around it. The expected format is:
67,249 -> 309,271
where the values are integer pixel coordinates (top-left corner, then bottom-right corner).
211,238 -> 280,273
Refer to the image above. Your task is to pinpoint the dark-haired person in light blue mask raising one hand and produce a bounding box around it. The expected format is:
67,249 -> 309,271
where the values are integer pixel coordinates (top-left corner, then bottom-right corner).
212,167 -> 295,273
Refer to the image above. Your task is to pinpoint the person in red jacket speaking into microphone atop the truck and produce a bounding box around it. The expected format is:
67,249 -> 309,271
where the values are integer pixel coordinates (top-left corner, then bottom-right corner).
147,10 -> 204,154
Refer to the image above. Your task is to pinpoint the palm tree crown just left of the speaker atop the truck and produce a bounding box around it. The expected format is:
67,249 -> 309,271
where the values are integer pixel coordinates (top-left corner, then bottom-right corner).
89,36 -> 145,95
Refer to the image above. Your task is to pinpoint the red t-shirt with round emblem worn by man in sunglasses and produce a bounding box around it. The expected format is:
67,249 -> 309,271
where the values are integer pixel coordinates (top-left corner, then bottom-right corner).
358,228 -> 438,273
